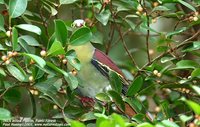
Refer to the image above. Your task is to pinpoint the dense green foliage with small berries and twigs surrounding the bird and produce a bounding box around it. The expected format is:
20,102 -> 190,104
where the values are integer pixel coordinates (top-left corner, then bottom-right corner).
0,0 -> 200,127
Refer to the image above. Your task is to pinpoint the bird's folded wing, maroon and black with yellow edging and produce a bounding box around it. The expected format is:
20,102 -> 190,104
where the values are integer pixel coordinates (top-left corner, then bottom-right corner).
91,49 -> 128,94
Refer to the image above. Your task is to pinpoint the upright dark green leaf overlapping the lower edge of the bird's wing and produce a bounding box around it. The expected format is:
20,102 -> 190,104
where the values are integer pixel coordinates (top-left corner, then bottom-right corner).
109,71 -> 122,93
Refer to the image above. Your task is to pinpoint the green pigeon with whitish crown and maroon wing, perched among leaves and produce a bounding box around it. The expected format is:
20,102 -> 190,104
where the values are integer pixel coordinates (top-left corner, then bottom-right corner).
68,19 -> 152,117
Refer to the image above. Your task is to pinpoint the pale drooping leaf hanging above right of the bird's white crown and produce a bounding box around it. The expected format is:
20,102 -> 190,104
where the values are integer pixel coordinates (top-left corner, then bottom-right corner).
95,9 -> 111,26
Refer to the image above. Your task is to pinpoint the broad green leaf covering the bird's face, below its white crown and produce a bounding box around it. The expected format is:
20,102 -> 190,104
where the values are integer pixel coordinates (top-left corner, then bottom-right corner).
70,27 -> 92,46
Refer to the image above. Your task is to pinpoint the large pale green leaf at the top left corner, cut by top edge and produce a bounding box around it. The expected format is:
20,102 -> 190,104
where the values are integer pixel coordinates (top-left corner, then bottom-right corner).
9,0 -> 27,18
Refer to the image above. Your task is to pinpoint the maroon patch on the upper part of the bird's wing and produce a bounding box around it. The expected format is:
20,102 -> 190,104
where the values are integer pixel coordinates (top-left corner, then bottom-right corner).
94,49 -> 124,77
